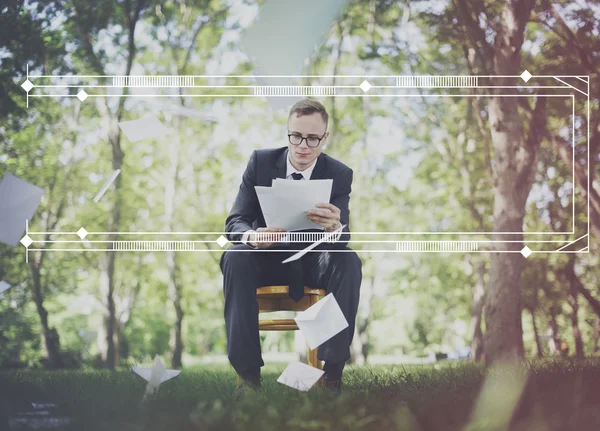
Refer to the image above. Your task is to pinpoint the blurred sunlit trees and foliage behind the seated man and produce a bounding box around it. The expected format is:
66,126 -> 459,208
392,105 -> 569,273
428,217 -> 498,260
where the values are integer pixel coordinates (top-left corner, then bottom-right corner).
0,0 -> 600,368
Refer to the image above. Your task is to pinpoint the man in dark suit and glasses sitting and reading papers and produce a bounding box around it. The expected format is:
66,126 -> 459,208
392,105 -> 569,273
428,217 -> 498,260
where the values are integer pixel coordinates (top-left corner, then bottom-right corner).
220,99 -> 362,391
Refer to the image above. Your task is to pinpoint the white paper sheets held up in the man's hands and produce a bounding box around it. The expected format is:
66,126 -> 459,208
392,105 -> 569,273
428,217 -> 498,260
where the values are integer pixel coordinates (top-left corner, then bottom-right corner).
255,179 -> 333,231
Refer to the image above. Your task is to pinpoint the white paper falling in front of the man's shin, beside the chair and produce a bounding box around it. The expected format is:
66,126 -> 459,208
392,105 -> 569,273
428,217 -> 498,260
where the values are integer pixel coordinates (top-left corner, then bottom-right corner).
294,293 -> 348,350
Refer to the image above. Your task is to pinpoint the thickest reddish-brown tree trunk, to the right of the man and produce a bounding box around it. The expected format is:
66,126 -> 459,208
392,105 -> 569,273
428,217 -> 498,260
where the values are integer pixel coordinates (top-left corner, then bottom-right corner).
484,1 -> 546,365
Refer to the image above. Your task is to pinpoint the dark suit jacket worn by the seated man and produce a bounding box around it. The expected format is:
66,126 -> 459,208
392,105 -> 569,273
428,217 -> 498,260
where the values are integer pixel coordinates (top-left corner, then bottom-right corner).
225,147 -> 353,248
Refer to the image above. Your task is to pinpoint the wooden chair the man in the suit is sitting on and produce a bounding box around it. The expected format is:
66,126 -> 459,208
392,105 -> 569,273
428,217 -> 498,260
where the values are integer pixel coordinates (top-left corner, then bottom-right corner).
237,286 -> 326,386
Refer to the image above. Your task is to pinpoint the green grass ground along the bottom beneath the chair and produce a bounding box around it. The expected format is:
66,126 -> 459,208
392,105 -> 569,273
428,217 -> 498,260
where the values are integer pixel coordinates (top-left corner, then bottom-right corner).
0,360 -> 600,431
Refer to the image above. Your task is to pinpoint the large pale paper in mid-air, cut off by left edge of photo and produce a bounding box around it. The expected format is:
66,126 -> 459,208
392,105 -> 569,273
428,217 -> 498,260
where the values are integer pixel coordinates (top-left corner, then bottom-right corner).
0,174 -> 44,247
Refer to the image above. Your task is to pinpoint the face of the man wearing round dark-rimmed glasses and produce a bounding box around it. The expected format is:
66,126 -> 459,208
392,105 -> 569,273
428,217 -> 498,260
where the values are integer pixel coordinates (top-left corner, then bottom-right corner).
288,112 -> 329,171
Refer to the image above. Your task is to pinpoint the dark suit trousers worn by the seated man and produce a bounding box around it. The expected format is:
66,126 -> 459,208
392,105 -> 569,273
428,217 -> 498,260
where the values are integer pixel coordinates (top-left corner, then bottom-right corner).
220,244 -> 362,373
